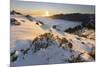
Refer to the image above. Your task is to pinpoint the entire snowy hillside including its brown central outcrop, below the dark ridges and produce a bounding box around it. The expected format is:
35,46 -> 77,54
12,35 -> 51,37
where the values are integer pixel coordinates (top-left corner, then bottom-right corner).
10,15 -> 95,67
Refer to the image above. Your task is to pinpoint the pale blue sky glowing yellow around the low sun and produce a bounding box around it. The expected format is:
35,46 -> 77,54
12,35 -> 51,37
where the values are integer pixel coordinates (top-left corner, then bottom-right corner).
11,0 -> 95,16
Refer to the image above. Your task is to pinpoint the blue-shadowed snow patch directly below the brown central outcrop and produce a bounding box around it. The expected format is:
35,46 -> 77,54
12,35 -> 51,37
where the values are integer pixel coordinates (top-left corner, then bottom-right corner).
11,43 -> 71,65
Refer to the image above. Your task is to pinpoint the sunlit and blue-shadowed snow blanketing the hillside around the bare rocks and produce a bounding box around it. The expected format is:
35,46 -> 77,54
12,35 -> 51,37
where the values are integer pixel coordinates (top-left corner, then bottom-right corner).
10,16 -> 95,67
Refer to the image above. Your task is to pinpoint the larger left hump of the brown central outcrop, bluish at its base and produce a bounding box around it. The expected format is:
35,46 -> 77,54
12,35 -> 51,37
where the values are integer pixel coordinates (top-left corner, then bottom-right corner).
32,33 -> 54,52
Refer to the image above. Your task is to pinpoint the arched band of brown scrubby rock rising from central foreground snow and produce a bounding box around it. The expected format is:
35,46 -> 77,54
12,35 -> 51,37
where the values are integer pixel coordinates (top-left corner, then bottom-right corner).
32,33 -> 73,52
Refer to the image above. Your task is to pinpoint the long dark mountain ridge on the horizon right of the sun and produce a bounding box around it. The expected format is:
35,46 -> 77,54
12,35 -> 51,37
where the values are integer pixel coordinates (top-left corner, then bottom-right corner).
51,13 -> 95,22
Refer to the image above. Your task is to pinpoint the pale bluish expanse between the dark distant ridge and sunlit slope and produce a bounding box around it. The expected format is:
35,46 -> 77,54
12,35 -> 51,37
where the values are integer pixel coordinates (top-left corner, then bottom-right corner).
36,17 -> 81,31
